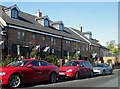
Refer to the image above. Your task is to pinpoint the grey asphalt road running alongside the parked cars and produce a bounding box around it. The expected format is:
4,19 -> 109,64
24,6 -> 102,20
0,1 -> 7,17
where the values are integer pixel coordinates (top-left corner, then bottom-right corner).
1,70 -> 120,89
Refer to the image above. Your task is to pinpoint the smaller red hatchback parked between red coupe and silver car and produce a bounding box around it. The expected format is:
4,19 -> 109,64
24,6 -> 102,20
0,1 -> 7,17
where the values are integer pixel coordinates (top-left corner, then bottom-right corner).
59,60 -> 93,79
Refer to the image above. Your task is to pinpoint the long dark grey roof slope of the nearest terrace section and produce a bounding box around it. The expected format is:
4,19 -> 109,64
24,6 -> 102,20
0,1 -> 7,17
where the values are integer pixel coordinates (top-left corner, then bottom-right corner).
0,6 -> 85,42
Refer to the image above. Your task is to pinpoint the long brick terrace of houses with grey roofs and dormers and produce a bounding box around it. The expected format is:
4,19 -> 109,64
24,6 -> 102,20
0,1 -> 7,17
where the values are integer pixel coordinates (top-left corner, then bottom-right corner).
0,5 -> 100,62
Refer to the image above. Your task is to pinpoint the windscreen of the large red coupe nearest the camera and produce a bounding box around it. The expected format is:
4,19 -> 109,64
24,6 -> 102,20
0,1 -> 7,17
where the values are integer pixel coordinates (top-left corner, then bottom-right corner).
7,60 -> 29,67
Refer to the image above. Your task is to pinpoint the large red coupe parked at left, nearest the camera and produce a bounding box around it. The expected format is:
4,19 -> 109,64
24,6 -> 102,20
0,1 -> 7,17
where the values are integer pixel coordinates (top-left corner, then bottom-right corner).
0,59 -> 59,88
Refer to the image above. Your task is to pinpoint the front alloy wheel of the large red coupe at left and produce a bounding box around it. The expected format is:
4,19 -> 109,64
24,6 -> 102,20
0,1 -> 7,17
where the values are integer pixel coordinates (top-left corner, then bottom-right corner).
8,75 -> 21,88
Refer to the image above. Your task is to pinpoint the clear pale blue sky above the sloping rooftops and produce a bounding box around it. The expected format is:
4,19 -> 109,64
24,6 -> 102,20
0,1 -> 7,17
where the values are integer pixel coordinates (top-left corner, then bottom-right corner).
2,2 -> 118,46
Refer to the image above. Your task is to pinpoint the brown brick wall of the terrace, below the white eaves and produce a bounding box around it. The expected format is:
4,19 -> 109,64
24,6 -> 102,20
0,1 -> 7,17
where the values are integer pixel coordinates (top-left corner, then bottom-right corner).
4,27 -> 94,59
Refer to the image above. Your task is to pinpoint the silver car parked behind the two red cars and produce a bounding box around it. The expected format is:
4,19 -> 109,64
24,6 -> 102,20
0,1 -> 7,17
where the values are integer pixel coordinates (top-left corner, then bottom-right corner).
93,63 -> 113,75
